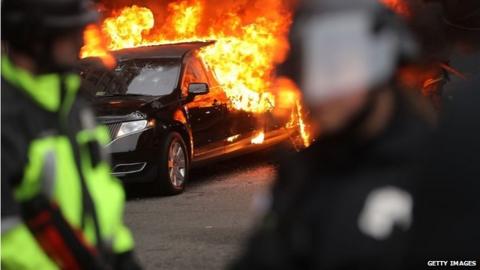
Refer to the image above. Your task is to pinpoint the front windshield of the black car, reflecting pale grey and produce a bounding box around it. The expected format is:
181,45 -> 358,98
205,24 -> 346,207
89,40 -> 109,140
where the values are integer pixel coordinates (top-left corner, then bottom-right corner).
83,60 -> 181,97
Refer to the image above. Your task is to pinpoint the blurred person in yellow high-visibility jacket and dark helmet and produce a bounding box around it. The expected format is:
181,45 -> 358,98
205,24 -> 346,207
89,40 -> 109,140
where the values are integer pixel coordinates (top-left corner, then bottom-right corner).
1,0 -> 139,270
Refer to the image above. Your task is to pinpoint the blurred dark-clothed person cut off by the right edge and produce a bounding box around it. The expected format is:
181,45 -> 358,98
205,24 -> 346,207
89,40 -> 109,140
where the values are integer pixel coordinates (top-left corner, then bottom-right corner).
408,0 -> 480,262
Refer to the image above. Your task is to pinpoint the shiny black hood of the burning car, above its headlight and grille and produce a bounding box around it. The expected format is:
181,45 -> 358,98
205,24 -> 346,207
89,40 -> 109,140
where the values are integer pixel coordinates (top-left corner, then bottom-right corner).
93,96 -> 166,123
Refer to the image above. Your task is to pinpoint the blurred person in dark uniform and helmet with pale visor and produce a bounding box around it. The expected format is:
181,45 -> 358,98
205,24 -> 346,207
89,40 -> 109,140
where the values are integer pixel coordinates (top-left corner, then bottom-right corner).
233,0 -> 436,270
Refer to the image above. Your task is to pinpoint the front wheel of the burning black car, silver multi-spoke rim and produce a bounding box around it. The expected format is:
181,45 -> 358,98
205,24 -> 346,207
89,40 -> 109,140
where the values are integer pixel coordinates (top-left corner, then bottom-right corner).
155,132 -> 189,195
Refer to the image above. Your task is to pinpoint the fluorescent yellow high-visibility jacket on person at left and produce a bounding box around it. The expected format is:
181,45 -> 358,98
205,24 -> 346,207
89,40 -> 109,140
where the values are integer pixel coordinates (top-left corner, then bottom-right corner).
1,57 -> 133,270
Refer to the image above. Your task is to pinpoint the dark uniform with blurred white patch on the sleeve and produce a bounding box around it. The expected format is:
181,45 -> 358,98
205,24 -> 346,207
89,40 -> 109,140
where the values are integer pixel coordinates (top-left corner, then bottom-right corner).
233,91 -> 430,270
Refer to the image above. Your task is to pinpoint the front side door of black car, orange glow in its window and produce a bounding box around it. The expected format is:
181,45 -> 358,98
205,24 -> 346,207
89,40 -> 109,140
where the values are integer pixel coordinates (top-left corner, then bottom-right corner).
182,57 -> 228,159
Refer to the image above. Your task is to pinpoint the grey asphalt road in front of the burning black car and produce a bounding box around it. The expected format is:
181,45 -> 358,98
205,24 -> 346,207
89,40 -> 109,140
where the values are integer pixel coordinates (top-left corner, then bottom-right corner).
125,150 -> 279,270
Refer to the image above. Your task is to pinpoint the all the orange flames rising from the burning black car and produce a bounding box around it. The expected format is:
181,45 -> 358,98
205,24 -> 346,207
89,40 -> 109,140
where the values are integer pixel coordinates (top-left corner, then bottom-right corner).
81,0 -> 312,147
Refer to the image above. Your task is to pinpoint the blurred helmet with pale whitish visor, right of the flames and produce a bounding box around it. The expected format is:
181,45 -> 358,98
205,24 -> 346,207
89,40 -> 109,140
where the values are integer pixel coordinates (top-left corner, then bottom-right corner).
278,0 -> 418,101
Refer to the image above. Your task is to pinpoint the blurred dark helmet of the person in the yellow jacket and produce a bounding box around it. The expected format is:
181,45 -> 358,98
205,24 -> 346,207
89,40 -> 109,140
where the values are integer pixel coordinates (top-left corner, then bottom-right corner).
2,0 -> 99,70
